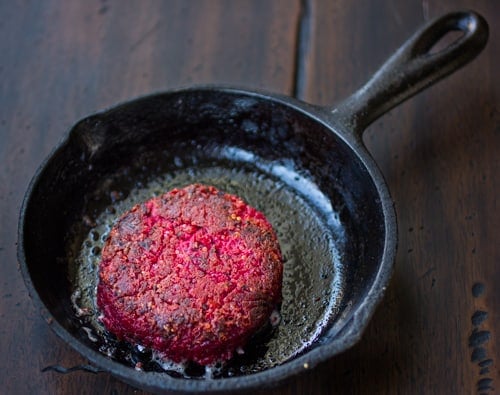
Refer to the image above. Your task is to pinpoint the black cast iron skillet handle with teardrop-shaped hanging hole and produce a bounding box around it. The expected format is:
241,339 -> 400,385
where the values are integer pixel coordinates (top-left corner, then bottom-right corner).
332,11 -> 488,138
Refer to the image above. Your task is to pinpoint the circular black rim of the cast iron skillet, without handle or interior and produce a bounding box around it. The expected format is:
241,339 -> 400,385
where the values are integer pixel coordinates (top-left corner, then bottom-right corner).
17,85 -> 397,393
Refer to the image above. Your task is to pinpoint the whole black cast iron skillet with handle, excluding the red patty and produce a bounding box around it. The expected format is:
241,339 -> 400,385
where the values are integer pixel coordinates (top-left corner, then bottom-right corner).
18,12 -> 488,393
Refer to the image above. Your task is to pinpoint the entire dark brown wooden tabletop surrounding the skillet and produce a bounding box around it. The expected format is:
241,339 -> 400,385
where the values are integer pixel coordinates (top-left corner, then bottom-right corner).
0,0 -> 500,394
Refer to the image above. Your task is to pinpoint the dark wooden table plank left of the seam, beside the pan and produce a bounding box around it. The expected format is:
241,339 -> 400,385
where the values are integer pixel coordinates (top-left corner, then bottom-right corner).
0,0 -> 299,394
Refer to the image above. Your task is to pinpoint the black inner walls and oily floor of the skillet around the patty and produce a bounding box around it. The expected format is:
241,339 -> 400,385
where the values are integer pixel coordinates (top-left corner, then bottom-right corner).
22,89 -> 384,379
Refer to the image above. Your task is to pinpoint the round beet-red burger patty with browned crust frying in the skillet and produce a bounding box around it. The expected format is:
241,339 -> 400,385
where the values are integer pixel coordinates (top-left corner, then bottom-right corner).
97,184 -> 283,365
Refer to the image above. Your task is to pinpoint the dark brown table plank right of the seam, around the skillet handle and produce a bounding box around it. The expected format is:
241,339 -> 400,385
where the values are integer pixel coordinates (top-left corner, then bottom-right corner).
304,1 -> 500,394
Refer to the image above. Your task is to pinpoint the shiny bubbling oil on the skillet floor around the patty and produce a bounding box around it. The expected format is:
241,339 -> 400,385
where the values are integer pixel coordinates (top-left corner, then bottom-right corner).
72,166 -> 343,378
